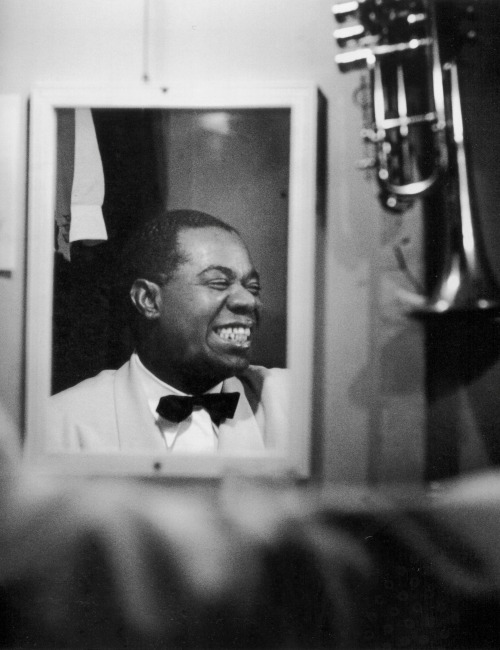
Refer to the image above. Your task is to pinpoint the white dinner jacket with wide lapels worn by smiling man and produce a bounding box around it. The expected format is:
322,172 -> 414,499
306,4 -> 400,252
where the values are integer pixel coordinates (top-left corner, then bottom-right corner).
45,360 -> 289,453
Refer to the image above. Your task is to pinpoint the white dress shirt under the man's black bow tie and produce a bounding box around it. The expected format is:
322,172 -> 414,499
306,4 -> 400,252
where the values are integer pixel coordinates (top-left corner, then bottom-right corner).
131,352 -> 222,454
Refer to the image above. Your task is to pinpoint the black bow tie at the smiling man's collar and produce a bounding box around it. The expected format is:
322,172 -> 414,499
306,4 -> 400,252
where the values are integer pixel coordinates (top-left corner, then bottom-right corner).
156,393 -> 240,426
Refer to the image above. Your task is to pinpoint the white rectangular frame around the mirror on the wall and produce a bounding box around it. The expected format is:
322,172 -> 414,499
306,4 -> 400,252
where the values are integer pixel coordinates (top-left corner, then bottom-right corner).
24,84 -> 321,477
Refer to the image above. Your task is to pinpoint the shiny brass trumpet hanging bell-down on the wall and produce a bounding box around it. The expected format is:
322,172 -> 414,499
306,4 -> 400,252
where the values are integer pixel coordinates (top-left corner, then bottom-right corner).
333,0 -> 500,317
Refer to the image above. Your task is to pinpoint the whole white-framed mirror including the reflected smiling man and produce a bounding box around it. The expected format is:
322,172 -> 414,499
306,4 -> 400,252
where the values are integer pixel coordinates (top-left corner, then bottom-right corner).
25,88 -> 319,475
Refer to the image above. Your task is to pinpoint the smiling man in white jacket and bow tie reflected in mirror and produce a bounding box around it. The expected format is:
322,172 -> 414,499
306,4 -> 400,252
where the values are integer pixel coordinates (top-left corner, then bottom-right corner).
49,210 -> 288,453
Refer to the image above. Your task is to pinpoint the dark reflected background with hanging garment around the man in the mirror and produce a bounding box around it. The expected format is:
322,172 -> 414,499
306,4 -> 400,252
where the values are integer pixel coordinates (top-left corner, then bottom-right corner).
52,109 -> 290,393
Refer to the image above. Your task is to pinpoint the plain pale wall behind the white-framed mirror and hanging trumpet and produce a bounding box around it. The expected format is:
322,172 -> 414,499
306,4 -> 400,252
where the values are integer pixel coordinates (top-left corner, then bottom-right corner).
0,0 -> 428,482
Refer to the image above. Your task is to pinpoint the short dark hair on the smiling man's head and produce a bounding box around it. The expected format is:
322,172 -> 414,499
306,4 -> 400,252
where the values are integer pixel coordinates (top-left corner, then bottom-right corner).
120,210 -> 240,289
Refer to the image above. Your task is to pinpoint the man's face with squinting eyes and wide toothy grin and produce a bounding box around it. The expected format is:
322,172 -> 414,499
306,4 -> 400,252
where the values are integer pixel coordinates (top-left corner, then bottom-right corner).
152,227 -> 261,392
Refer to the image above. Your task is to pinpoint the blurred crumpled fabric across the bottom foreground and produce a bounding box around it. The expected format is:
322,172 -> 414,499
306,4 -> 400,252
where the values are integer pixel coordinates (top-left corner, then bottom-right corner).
0,412 -> 500,650
